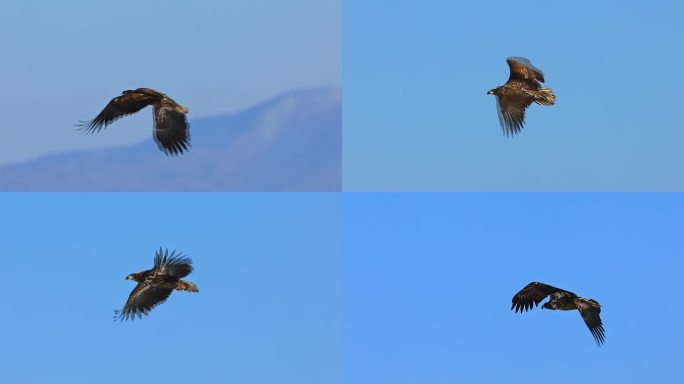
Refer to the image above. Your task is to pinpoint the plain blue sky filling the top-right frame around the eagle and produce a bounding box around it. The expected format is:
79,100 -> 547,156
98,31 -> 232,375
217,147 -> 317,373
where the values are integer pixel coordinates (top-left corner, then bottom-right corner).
343,0 -> 684,191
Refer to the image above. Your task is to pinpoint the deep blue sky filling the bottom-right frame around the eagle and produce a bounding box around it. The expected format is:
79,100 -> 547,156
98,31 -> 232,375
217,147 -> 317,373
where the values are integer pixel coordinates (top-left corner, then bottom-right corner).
343,194 -> 684,384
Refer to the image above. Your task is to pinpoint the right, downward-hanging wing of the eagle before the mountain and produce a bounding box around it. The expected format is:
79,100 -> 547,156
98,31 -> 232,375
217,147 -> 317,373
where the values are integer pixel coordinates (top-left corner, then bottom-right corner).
154,103 -> 190,156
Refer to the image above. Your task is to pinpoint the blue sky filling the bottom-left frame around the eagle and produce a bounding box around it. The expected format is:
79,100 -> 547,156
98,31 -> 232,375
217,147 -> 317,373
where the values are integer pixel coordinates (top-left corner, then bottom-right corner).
0,193 -> 341,384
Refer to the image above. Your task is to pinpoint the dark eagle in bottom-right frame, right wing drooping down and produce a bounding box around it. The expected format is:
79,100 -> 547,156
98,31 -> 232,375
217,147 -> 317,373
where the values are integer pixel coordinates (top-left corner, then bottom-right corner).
511,281 -> 606,346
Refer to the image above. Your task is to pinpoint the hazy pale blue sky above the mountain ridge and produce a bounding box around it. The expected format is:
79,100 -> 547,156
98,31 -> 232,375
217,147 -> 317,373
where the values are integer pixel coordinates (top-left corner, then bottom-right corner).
0,0 -> 342,164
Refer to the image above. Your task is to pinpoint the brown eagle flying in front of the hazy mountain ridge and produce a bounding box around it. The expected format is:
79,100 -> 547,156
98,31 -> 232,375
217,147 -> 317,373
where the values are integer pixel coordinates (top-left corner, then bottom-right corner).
80,88 -> 190,155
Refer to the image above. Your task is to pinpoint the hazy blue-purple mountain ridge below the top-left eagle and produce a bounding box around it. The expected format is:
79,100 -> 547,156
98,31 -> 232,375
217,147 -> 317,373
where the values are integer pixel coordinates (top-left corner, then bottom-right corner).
0,88 -> 342,191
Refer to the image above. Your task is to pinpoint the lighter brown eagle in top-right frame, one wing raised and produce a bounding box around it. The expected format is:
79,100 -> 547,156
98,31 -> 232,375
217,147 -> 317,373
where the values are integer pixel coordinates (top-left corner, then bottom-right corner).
487,57 -> 556,136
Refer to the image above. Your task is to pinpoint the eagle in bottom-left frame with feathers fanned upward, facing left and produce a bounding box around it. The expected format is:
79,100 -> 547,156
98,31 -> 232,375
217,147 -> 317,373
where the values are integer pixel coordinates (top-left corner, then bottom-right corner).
114,248 -> 197,321
